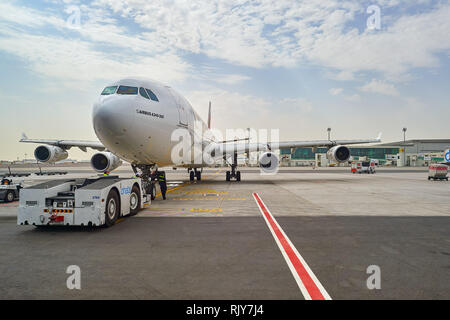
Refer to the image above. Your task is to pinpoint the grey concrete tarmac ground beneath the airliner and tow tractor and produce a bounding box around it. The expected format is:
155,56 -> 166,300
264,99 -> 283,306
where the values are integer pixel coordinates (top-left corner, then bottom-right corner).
0,168 -> 450,299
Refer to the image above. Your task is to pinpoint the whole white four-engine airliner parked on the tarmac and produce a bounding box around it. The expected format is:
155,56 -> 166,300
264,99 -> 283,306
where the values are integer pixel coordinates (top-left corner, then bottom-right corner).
20,78 -> 381,181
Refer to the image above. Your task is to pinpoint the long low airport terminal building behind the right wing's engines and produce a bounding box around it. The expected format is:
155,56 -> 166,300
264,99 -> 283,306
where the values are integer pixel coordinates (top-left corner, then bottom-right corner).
280,139 -> 450,167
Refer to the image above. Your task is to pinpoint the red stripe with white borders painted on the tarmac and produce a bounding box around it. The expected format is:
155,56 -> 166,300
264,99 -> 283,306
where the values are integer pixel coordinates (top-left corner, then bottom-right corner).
253,193 -> 331,300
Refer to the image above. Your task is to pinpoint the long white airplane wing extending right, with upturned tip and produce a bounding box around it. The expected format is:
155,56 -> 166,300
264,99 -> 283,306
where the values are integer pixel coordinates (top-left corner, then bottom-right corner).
219,133 -> 381,155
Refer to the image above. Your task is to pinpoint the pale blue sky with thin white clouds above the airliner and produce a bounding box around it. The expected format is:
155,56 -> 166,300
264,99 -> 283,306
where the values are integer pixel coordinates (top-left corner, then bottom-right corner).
0,0 -> 450,160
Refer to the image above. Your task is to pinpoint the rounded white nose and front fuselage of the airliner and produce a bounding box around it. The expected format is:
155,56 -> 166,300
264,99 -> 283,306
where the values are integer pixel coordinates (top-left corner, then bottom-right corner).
93,79 -> 206,167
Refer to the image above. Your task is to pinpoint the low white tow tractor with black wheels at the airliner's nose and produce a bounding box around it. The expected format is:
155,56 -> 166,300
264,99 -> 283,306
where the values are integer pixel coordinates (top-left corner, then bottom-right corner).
17,176 -> 150,226
